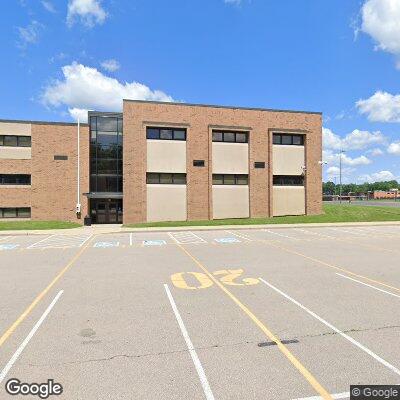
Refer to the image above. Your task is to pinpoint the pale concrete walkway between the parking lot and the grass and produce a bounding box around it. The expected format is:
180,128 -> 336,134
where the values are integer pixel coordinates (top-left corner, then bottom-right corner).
0,221 -> 400,236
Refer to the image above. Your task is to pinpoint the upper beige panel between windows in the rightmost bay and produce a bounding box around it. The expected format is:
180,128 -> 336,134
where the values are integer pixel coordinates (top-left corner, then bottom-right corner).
272,145 -> 305,175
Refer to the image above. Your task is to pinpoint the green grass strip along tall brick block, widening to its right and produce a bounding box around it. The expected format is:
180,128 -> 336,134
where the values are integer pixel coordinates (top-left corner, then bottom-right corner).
124,204 -> 400,228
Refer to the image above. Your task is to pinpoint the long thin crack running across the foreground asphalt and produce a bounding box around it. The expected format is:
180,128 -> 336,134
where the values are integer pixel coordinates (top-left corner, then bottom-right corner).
27,325 -> 400,367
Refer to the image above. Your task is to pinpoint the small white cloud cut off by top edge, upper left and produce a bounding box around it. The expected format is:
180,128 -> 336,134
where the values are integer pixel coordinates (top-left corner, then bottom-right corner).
67,0 -> 107,28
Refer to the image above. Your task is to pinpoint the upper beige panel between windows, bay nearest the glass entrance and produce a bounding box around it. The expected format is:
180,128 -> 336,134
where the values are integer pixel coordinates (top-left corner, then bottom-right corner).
147,140 -> 186,173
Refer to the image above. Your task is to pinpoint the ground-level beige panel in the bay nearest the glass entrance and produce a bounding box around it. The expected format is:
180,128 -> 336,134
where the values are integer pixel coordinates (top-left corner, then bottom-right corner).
147,184 -> 187,222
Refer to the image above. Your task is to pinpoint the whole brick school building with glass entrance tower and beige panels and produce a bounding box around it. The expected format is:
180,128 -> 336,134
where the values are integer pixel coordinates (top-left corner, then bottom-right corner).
0,100 -> 322,223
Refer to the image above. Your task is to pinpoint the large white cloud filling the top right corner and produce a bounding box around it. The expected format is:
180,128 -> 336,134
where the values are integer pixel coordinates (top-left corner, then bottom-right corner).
361,0 -> 400,56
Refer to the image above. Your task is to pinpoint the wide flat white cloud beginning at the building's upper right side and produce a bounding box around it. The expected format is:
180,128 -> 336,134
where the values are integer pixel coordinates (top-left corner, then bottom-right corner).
322,128 -> 386,150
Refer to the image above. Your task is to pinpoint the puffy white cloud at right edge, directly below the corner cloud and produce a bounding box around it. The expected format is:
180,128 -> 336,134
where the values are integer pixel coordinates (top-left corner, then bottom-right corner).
356,90 -> 400,122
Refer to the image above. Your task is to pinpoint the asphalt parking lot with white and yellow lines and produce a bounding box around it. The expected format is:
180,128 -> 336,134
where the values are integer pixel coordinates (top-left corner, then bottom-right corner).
0,225 -> 400,400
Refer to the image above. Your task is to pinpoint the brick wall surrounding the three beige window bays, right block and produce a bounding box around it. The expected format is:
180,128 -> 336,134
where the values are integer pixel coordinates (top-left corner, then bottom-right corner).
124,101 -> 322,223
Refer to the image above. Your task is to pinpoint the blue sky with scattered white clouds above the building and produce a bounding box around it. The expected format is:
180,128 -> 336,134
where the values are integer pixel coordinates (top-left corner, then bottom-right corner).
0,0 -> 400,183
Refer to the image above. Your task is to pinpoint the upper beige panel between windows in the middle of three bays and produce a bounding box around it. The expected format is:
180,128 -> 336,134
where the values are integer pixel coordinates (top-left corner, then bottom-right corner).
212,142 -> 249,174
